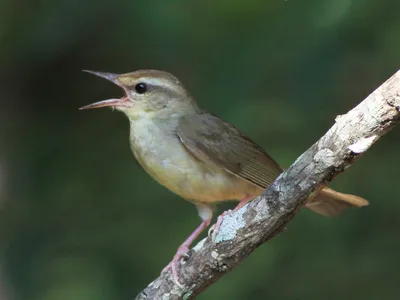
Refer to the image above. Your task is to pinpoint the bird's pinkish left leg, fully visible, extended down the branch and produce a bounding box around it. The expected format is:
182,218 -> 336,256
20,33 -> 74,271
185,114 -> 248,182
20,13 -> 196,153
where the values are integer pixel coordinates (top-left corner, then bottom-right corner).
161,205 -> 213,287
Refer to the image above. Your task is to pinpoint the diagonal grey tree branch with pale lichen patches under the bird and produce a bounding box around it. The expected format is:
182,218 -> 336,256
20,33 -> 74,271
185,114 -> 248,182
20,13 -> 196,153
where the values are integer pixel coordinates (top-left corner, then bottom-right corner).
136,71 -> 400,300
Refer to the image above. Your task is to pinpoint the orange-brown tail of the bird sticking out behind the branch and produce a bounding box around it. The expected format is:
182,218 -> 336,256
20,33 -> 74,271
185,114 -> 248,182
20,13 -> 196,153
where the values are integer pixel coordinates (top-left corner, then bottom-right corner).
306,187 -> 368,217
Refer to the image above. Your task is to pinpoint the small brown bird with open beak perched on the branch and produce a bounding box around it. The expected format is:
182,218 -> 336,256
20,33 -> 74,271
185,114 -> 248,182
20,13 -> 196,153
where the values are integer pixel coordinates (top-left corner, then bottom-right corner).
81,70 -> 368,284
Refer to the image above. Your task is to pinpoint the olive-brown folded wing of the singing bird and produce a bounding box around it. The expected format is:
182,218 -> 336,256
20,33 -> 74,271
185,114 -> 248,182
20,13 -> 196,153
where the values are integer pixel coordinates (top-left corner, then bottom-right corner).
177,113 -> 282,188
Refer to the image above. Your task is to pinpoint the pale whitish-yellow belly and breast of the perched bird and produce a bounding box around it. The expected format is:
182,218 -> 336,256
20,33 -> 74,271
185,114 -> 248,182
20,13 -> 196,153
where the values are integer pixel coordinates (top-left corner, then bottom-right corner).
131,121 -> 262,202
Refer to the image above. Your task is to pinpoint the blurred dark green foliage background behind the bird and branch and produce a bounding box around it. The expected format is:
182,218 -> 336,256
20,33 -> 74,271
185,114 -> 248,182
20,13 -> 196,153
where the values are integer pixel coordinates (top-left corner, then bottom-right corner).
0,0 -> 400,300
